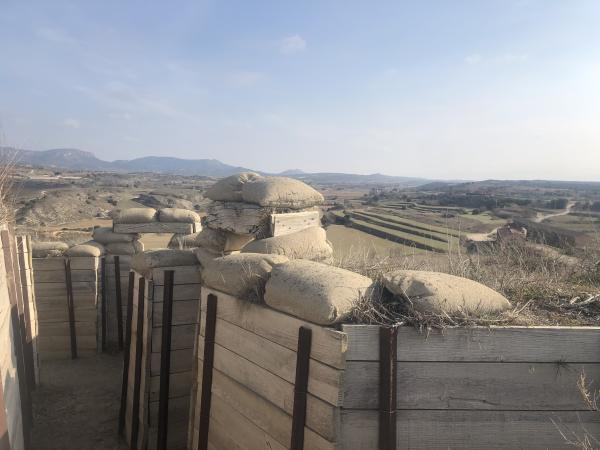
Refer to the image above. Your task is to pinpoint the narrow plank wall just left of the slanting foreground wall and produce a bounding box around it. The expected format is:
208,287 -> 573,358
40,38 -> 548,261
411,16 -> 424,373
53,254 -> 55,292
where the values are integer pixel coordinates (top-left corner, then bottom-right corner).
124,251 -> 200,450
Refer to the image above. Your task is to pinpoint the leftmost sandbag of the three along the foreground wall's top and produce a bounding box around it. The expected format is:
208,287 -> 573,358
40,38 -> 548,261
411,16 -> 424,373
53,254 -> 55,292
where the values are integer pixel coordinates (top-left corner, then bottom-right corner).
200,253 -> 288,300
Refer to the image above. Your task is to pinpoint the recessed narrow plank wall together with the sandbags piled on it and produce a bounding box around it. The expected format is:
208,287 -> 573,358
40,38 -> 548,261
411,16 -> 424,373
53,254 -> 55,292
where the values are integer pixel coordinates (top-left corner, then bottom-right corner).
92,227 -> 144,350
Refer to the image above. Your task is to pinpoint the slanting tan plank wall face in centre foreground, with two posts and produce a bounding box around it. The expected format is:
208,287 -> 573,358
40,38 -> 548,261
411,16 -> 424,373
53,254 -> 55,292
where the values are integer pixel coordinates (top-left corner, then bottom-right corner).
189,287 -> 346,450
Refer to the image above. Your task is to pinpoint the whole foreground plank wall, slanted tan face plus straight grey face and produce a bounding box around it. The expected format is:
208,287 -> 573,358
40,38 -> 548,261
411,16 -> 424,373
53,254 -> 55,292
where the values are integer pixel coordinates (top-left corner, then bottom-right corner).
188,288 -> 600,450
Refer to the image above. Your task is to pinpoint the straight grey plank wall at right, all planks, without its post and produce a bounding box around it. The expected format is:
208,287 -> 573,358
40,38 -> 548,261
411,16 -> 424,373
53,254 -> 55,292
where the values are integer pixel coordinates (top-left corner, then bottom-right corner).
342,325 -> 600,450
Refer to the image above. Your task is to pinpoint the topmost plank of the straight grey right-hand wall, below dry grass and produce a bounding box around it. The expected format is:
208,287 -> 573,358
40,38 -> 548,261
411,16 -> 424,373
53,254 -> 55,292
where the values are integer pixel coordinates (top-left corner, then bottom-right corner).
342,325 -> 600,363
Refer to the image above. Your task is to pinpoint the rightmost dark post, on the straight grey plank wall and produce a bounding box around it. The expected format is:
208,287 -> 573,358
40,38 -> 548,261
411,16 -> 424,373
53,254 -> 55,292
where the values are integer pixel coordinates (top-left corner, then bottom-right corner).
379,327 -> 398,450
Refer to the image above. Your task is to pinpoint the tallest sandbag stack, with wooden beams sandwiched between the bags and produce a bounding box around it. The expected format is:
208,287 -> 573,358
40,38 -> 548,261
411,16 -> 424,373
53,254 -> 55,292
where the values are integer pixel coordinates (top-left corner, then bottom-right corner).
194,172 -> 332,259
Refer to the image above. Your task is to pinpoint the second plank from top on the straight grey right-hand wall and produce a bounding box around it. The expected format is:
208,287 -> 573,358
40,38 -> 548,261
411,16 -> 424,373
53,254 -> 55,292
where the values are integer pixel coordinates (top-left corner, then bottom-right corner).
344,361 -> 600,411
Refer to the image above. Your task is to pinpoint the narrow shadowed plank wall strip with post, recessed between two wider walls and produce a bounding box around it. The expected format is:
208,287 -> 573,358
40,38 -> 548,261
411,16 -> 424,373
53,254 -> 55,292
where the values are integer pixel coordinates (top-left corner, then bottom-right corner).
104,255 -> 131,352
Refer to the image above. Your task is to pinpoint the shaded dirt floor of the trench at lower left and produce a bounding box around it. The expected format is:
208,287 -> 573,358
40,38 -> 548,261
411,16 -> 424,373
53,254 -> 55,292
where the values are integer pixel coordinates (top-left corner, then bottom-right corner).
32,355 -> 127,450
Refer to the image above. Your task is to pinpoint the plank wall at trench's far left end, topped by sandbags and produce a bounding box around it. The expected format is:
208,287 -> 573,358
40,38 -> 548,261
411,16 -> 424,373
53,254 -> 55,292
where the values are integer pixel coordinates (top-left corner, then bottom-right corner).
32,241 -> 104,360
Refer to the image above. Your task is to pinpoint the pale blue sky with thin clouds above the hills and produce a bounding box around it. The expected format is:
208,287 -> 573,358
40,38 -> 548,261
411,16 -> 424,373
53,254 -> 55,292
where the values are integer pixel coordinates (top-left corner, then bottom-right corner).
0,0 -> 600,181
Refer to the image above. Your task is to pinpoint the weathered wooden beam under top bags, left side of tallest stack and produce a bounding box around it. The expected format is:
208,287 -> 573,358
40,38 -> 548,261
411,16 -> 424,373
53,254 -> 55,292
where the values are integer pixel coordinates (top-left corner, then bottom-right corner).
203,202 -> 274,237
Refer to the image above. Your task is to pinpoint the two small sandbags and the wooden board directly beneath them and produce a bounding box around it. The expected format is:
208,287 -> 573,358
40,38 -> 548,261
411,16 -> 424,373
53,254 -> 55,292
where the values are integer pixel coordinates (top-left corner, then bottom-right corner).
112,208 -> 201,234
